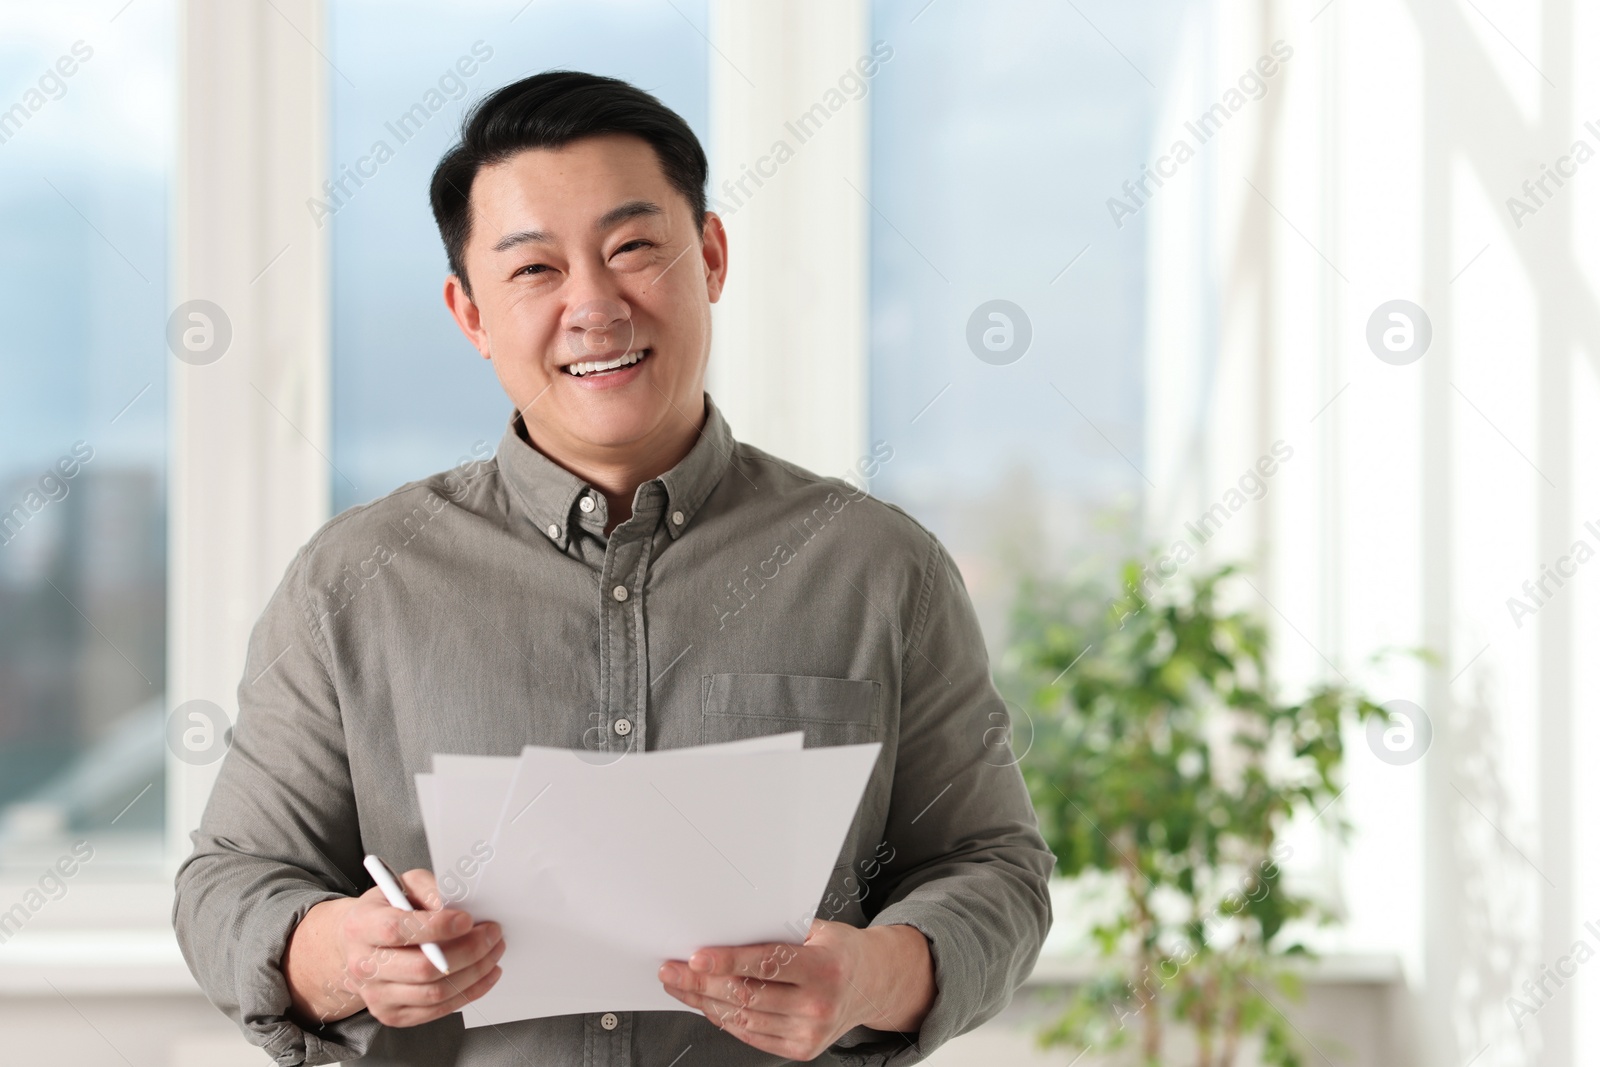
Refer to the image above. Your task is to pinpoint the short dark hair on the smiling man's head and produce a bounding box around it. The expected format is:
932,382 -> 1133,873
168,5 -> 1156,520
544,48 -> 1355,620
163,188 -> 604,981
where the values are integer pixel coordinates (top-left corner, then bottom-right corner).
429,70 -> 707,294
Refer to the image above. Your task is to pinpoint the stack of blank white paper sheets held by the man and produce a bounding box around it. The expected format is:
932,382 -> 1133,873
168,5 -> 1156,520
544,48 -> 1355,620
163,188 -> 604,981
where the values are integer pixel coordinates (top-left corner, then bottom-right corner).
416,733 -> 882,1027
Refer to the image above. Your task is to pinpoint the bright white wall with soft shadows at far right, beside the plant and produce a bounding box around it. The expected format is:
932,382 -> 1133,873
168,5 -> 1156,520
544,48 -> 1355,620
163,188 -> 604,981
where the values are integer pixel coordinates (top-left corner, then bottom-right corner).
1150,0 -> 1600,1065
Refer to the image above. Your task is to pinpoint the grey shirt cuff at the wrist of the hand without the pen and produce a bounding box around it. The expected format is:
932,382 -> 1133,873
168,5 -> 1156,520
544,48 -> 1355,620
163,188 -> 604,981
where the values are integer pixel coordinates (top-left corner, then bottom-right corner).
835,899 -> 987,1067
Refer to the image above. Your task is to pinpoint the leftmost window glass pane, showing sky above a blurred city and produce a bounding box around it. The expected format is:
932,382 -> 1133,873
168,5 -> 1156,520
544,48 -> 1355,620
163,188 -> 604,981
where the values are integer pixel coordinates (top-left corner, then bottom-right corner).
0,0 -> 174,877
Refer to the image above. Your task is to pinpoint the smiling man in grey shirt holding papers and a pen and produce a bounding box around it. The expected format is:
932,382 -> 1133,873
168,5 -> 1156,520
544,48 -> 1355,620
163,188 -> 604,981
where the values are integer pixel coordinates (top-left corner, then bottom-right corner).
174,72 -> 1054,1067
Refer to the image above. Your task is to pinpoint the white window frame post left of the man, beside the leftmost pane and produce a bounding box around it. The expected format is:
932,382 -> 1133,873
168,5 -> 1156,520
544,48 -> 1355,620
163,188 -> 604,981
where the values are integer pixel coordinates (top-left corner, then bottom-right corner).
166,0 -> 331,873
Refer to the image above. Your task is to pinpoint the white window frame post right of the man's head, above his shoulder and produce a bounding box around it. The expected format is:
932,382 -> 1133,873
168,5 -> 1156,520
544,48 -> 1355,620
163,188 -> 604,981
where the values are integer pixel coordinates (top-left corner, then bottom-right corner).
707,0 -> 872,477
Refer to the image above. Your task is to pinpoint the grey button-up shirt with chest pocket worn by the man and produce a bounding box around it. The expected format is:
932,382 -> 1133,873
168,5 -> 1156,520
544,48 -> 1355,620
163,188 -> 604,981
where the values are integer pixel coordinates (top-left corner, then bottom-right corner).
173,398 -> 1054,1067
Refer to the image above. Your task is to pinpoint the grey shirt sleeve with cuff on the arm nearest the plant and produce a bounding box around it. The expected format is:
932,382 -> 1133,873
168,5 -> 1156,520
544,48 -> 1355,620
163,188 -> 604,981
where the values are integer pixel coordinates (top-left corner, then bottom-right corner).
835,541 -> 1056,1067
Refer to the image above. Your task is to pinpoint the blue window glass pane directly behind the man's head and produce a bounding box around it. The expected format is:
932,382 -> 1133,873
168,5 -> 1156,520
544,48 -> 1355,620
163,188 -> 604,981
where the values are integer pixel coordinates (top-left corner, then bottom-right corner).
329,0 -> 707,510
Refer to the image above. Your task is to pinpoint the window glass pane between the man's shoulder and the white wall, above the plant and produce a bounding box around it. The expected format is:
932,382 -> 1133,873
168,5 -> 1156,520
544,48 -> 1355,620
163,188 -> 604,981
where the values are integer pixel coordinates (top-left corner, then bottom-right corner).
870,0 -> 1189,640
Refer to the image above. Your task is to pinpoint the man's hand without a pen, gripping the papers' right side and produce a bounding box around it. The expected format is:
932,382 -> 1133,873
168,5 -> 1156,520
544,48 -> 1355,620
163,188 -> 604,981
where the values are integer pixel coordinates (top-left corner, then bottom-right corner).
659,920 -> 934,1061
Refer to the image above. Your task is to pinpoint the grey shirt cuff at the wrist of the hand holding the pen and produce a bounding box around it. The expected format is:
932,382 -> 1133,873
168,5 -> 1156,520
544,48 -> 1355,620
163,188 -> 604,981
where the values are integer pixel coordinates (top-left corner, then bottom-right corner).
224,889 -> 382,1067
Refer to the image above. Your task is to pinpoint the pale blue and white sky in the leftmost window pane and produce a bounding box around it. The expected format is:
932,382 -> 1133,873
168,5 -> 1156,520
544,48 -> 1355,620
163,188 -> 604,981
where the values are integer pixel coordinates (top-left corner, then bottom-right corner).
0,0 -> 174,483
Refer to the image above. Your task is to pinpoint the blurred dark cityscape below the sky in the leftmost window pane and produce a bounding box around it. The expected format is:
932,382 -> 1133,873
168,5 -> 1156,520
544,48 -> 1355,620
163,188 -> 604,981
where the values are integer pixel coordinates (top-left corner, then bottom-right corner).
0,464 -> 166,872
